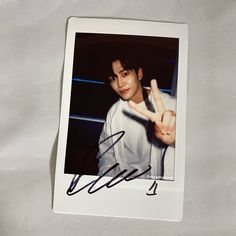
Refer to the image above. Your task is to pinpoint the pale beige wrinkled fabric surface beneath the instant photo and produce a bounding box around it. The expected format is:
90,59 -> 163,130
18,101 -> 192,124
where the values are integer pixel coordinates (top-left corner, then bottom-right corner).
0,0 -> 236,236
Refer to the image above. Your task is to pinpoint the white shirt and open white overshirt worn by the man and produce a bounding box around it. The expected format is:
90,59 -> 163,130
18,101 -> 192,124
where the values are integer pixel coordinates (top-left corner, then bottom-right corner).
98,93 -> 176,179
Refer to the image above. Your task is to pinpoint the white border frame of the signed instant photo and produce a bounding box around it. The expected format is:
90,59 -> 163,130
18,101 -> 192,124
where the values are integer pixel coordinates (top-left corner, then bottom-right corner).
53,17 -> 188,221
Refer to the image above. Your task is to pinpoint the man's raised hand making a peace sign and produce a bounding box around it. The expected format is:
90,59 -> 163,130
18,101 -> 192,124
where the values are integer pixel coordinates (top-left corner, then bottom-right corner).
129,80 -> 176,145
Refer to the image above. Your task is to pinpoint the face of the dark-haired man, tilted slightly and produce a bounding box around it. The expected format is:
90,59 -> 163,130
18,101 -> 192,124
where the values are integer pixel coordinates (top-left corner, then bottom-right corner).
109,60 -> 143,103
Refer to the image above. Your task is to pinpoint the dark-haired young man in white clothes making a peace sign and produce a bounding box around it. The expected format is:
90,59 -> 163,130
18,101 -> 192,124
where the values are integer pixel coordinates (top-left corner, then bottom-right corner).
97,57 -> 176,180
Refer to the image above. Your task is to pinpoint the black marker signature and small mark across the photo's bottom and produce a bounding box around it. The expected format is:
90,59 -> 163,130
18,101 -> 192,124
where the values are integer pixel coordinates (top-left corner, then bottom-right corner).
66,131 -> 157,196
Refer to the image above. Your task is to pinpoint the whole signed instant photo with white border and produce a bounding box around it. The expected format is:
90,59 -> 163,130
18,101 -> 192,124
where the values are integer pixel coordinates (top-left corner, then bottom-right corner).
53,17 -> 187,221
